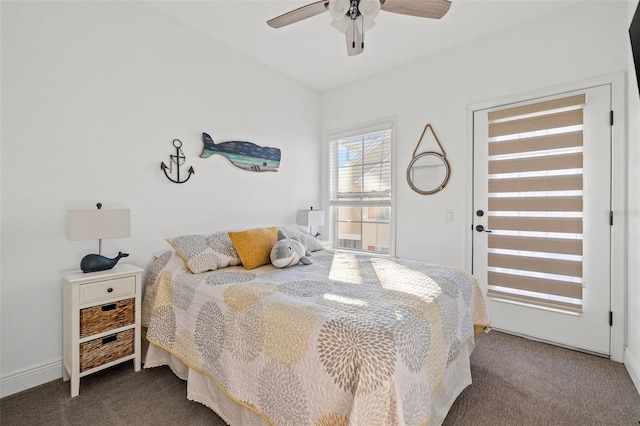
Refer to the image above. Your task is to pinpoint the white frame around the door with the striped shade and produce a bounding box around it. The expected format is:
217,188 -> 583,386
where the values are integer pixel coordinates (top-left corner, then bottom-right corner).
465,72 -> 627,362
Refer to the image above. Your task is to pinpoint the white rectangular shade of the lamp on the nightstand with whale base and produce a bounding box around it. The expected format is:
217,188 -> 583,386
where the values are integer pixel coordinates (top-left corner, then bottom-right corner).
67,209 -> 131,241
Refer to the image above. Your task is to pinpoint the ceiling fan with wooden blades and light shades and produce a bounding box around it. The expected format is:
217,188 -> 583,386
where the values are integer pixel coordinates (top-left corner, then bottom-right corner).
267,0 -> 451,56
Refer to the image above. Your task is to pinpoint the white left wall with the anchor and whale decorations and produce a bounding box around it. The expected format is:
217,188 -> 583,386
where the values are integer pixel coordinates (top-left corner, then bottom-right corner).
0,1 -> 320,396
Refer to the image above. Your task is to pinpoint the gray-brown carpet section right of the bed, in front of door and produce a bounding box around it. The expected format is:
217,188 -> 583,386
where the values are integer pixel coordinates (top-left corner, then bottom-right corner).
444,331 -> 640,426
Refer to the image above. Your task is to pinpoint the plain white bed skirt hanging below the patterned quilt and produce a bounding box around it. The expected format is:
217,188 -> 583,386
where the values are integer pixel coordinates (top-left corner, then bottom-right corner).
144,338 -> 475,426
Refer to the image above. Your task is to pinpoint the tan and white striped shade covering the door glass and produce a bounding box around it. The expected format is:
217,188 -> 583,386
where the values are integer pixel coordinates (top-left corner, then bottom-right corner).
487,94 -> 586,312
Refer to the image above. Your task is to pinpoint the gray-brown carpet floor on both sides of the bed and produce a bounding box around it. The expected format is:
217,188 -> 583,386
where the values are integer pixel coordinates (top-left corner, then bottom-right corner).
0,331 -> 640,426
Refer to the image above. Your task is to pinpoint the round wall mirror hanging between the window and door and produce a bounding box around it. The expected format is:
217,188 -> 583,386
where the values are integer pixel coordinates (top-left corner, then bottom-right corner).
407,151 -> 451,195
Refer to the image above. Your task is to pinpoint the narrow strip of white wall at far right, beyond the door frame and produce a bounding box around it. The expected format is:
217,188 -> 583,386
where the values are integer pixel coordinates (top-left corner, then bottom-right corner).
624,0 -> 640,392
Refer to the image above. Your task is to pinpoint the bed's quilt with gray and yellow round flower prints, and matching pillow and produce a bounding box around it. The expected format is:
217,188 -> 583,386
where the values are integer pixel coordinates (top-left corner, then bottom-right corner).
142,228 -> 489,426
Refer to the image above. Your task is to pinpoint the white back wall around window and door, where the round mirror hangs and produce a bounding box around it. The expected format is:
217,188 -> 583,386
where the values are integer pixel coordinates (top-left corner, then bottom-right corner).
322,1 -> 640,389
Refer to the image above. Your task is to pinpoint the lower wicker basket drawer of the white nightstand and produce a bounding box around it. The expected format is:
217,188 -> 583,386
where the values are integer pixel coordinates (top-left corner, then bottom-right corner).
80,329 -> 135,372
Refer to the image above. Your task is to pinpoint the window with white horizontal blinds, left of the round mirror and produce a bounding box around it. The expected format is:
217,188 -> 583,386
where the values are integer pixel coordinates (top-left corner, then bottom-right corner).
329,121 -> 393,254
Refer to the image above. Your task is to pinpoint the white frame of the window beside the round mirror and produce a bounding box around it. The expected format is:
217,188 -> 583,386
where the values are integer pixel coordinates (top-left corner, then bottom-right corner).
325,117 -> 397,256
